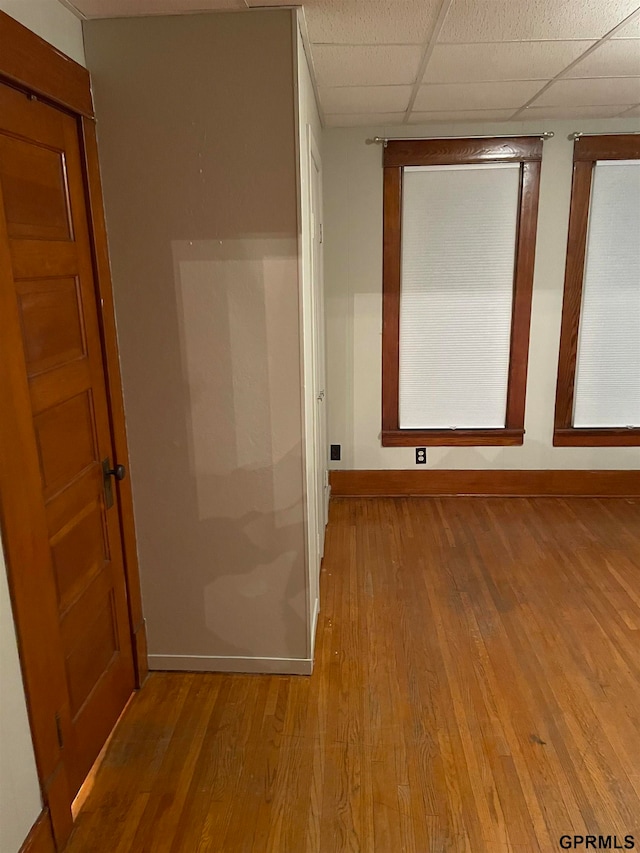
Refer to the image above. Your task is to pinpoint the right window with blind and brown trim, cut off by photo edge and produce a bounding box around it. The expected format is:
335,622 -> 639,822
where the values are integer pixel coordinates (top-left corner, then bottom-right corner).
553,134 -> 640,446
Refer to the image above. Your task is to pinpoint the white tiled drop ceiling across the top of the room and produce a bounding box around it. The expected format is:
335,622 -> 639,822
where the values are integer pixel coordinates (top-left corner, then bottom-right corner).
61,0 -> 640,126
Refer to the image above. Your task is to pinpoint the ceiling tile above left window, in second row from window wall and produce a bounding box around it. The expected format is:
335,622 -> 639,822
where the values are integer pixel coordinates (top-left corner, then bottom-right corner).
414,80 -> 545,112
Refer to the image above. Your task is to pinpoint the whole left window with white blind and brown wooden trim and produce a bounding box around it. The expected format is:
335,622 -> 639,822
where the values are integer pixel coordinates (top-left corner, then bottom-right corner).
382,137 -> 542,447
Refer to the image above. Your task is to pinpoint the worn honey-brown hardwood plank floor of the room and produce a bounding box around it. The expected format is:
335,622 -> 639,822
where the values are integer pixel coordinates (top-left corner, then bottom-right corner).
67,498 -> 640,853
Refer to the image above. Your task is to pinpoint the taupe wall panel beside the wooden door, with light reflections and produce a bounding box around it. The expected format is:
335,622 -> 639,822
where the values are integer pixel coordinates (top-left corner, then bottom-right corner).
84,10 -> 309,672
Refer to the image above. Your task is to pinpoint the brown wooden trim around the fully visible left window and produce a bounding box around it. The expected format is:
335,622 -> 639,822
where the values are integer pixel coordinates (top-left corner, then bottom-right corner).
381,136 -> 542,447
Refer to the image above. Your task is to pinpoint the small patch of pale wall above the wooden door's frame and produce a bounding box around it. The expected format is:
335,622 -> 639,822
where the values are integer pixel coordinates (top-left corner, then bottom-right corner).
0,0 -> 85,65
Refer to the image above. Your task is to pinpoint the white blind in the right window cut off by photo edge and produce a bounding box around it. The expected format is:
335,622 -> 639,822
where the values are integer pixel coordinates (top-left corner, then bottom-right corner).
573,160 -> 640,427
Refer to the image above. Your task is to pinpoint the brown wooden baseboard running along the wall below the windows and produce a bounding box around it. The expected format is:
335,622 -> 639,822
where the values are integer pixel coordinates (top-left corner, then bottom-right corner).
329,470 -> 640,497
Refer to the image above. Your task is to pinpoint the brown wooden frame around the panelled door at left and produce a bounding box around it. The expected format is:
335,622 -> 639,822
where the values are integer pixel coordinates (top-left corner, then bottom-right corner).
0,11 -> 148,848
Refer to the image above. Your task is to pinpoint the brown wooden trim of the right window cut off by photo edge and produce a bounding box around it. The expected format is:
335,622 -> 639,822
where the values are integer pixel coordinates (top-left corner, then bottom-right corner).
553,134 -> 640,447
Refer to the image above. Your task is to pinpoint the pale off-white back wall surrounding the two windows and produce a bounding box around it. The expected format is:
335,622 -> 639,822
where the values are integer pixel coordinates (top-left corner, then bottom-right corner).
324,119 -> 640,469
